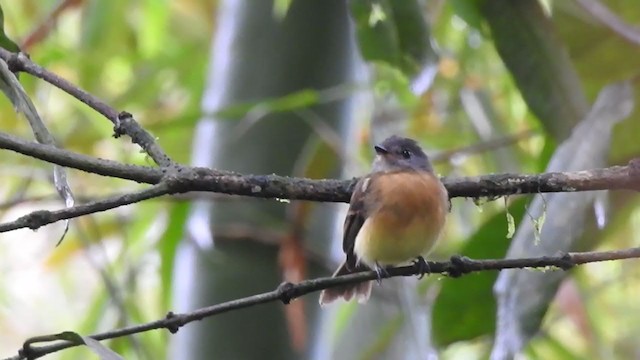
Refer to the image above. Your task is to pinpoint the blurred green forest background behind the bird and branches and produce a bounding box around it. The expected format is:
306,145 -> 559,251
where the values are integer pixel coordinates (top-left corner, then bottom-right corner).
0,0 -> 640,359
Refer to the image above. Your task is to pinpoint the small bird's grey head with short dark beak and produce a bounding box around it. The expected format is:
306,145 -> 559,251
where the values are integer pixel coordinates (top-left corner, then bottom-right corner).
373,135 -> 433,172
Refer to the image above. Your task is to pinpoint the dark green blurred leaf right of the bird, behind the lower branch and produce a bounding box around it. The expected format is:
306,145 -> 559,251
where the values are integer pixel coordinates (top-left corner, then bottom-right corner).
432,199 -> 526,346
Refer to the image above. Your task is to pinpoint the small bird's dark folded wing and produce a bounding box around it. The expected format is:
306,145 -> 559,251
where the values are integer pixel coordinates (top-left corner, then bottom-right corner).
342,177 -> 373,271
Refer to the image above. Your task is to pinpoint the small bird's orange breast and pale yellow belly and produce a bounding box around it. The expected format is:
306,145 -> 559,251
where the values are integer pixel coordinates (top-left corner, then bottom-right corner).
354,172 -> 448,266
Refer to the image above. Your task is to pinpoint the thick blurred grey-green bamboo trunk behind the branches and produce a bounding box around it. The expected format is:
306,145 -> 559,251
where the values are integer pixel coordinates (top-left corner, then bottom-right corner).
170,0 -> 355,359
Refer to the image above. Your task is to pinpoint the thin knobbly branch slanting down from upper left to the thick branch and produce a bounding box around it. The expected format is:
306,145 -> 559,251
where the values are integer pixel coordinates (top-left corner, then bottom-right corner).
0,48 -> 173,167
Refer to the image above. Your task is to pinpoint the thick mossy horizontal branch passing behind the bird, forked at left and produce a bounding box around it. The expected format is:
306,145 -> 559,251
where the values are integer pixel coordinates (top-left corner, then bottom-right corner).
0,133 -> 640,232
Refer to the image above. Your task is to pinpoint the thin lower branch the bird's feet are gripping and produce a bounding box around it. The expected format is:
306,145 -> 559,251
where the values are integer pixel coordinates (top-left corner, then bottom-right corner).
11,247 -> 640,360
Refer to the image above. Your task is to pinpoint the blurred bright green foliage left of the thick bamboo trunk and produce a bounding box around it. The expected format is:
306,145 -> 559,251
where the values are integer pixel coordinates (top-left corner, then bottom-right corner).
0,0 -> 216,359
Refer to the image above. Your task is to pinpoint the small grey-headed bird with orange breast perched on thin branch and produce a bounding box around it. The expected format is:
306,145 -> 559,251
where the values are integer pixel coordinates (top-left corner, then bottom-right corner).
320,136 -> 449,305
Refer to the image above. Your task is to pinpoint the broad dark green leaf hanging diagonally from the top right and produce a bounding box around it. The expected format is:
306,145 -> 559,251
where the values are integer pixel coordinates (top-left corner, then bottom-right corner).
477,0 -> 589,140
